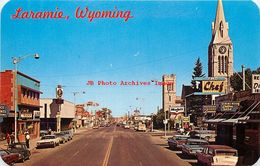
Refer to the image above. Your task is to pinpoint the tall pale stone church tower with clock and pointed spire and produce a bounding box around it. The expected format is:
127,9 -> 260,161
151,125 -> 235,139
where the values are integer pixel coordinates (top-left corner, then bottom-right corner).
208,0 -> 233,79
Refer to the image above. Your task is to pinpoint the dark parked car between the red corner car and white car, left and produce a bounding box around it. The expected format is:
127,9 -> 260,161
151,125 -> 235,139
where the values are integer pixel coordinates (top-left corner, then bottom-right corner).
7,142 -> 31,162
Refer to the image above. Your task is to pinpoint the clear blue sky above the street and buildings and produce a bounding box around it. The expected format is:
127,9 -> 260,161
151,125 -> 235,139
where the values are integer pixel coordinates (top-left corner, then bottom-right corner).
1,1 -> 260,116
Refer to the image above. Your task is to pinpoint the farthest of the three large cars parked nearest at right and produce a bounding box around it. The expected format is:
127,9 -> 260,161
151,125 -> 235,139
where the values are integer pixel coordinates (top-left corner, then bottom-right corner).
168,135 -> 190,149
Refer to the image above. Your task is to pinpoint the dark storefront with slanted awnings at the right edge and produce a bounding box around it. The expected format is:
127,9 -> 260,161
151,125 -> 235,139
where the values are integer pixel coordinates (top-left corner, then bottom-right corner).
205,91 -> 260,165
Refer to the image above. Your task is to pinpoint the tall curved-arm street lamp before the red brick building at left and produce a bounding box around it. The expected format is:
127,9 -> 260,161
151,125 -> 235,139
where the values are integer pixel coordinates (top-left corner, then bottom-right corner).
12,53 -> 40,142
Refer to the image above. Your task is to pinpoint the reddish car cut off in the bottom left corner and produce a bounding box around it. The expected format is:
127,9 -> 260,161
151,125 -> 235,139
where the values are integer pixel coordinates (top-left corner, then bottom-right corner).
0,149 -> 21,165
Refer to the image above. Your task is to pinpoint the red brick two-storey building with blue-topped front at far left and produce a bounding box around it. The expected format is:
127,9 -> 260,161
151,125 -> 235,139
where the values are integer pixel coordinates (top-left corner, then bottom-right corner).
0,70 -> 41,141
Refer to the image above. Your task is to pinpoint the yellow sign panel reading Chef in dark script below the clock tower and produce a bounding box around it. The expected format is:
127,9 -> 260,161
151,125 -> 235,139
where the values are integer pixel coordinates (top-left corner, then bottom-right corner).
202,81 -> 226,93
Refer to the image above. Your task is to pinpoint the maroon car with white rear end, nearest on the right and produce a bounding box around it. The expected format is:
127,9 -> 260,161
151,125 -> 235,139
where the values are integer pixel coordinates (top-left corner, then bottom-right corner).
197,145 -> 238,166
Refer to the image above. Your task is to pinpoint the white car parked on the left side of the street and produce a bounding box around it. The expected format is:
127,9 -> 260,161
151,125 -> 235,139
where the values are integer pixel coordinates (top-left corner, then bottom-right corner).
36,135 -> 60,148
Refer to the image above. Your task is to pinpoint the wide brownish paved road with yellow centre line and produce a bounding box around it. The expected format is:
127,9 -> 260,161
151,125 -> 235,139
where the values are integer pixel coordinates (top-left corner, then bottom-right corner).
19,126 -> 189,166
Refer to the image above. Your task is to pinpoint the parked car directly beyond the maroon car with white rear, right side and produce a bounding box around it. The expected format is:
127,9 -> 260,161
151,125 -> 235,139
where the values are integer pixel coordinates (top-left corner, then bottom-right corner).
181,139 -> 209,156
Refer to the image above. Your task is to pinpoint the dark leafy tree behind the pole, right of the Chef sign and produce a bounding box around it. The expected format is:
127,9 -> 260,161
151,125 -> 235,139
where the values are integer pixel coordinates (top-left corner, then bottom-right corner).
230,67 -> 260,91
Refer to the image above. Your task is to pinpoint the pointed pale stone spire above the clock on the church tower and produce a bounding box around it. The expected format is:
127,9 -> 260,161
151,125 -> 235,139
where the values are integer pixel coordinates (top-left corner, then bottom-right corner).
211,0 -> 231,44
